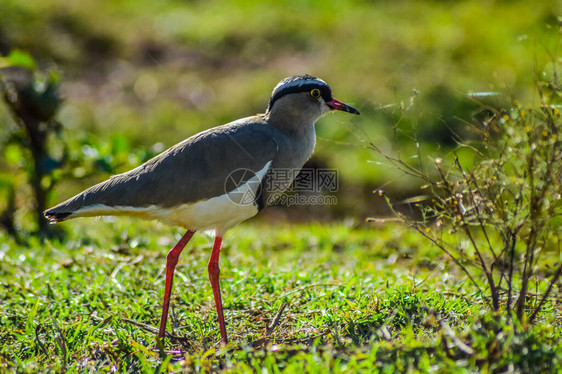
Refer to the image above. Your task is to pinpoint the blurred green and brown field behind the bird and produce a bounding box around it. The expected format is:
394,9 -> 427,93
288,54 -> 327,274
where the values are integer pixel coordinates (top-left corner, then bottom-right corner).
0,0 -> 561,231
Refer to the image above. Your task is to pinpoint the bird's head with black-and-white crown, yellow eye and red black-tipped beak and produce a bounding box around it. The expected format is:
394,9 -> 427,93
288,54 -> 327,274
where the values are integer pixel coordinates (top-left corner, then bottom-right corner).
267,75 -> 359,124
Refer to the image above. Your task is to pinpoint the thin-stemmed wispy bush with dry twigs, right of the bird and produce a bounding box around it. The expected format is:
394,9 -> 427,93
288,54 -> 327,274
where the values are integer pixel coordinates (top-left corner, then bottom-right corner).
371,60 -> 562,322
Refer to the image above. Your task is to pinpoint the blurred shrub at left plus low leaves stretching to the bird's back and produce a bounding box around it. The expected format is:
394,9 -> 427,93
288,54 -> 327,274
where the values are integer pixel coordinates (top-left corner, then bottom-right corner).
0,50 -> 163,240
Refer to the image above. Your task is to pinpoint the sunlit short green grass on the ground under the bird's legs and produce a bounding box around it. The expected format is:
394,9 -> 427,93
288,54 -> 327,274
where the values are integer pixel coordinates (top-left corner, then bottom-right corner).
0,219 -> 562,373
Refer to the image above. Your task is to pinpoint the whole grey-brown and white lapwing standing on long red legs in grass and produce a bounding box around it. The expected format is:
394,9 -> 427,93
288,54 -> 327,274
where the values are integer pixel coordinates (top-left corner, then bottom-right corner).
45,75 -> 359,343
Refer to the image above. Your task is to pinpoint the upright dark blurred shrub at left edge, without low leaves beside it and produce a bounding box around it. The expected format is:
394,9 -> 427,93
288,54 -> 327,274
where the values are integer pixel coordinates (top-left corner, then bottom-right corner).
0,50 -> 64,236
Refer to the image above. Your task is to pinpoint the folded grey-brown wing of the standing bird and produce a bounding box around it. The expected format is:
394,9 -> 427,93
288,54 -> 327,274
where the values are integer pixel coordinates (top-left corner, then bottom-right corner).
45,117 -> 278,221
